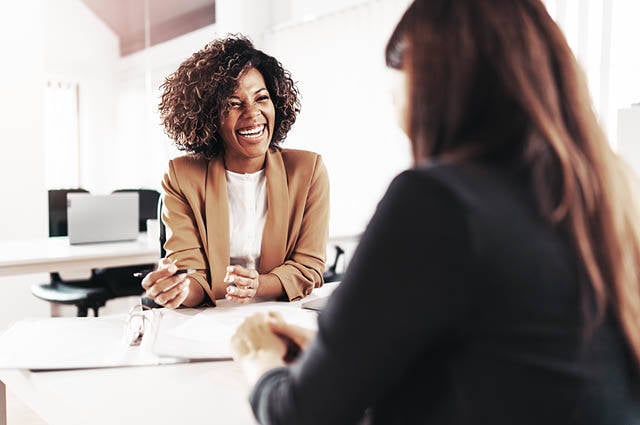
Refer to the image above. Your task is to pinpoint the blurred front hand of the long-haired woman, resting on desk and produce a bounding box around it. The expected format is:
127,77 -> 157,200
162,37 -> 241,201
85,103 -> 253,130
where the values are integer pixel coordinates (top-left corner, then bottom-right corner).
231,313 -> 287,385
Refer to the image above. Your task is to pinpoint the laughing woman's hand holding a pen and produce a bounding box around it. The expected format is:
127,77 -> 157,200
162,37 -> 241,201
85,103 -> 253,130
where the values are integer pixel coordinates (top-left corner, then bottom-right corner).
142,258 -> 189,308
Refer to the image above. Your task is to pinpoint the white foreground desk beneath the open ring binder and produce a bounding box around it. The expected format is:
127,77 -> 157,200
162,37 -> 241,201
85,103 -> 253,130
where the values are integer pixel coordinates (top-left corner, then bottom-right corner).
0,283 -> 338,425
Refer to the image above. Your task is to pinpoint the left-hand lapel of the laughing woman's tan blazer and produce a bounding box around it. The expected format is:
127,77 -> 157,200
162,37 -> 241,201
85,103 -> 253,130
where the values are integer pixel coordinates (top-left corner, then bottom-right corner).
205,156 -> 229,298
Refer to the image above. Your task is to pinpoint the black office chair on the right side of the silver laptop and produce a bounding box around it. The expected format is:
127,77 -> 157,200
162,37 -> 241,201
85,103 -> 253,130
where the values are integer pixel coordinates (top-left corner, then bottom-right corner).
96,189 -> 160,298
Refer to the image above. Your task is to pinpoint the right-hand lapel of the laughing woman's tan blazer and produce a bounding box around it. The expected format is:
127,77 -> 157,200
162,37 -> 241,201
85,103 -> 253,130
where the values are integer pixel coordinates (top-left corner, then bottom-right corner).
258,149 -> 289,274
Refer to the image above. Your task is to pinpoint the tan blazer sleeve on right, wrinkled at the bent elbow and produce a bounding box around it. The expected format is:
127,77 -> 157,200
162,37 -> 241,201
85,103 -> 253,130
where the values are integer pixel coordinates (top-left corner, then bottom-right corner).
270,155 -> 329,301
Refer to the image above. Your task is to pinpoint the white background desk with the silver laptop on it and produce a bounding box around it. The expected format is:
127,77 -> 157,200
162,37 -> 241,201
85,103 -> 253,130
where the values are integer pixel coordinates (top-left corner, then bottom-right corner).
0,233 -> 160,276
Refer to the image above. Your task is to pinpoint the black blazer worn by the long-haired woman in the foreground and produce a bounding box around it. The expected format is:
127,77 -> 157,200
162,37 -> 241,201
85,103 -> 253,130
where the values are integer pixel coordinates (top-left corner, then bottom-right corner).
251,163 -> 640,425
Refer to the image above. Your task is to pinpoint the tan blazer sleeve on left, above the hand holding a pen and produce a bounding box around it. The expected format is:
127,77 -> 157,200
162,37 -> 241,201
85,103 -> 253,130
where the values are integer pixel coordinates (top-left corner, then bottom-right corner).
162,161 -> 215,300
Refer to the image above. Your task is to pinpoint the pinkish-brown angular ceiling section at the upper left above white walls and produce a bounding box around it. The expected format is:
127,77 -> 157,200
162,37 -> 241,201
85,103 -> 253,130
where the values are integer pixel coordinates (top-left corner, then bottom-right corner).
82,0 -> 215,56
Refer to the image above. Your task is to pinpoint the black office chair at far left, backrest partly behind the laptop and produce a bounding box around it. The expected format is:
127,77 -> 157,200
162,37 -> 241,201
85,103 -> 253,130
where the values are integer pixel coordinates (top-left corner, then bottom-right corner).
31,189 -> 110,317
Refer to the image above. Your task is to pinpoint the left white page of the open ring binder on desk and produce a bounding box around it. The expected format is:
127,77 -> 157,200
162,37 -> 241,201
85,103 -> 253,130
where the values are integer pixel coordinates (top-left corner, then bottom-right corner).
0,315 -> 177,370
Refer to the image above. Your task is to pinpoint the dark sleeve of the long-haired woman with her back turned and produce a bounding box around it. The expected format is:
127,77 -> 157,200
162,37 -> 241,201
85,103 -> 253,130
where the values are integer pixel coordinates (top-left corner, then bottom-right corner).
251,171 -> 471,425
